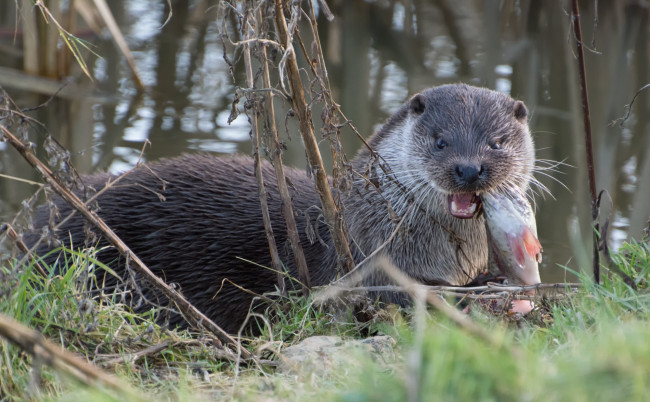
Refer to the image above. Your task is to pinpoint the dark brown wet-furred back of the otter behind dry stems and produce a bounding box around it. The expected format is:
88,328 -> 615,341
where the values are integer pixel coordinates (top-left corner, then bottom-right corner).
29,155 -> 333,332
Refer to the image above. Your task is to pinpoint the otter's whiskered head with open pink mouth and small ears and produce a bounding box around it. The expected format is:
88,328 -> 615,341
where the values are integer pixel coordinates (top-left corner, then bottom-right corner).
404,85 -> 535,218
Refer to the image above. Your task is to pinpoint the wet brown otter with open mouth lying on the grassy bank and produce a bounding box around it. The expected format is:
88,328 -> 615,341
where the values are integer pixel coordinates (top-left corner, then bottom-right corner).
26,84 -> 535,333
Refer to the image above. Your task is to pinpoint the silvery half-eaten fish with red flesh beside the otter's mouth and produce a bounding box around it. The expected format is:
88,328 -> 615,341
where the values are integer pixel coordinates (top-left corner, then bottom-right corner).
481,188 -> 542,313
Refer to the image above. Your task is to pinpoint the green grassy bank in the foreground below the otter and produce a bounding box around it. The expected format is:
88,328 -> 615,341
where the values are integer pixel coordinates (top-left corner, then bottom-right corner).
0,242 -> 650,401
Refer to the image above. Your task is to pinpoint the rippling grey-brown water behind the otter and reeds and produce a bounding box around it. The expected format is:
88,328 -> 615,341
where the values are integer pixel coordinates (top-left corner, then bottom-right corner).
0,0 -> 650,281
